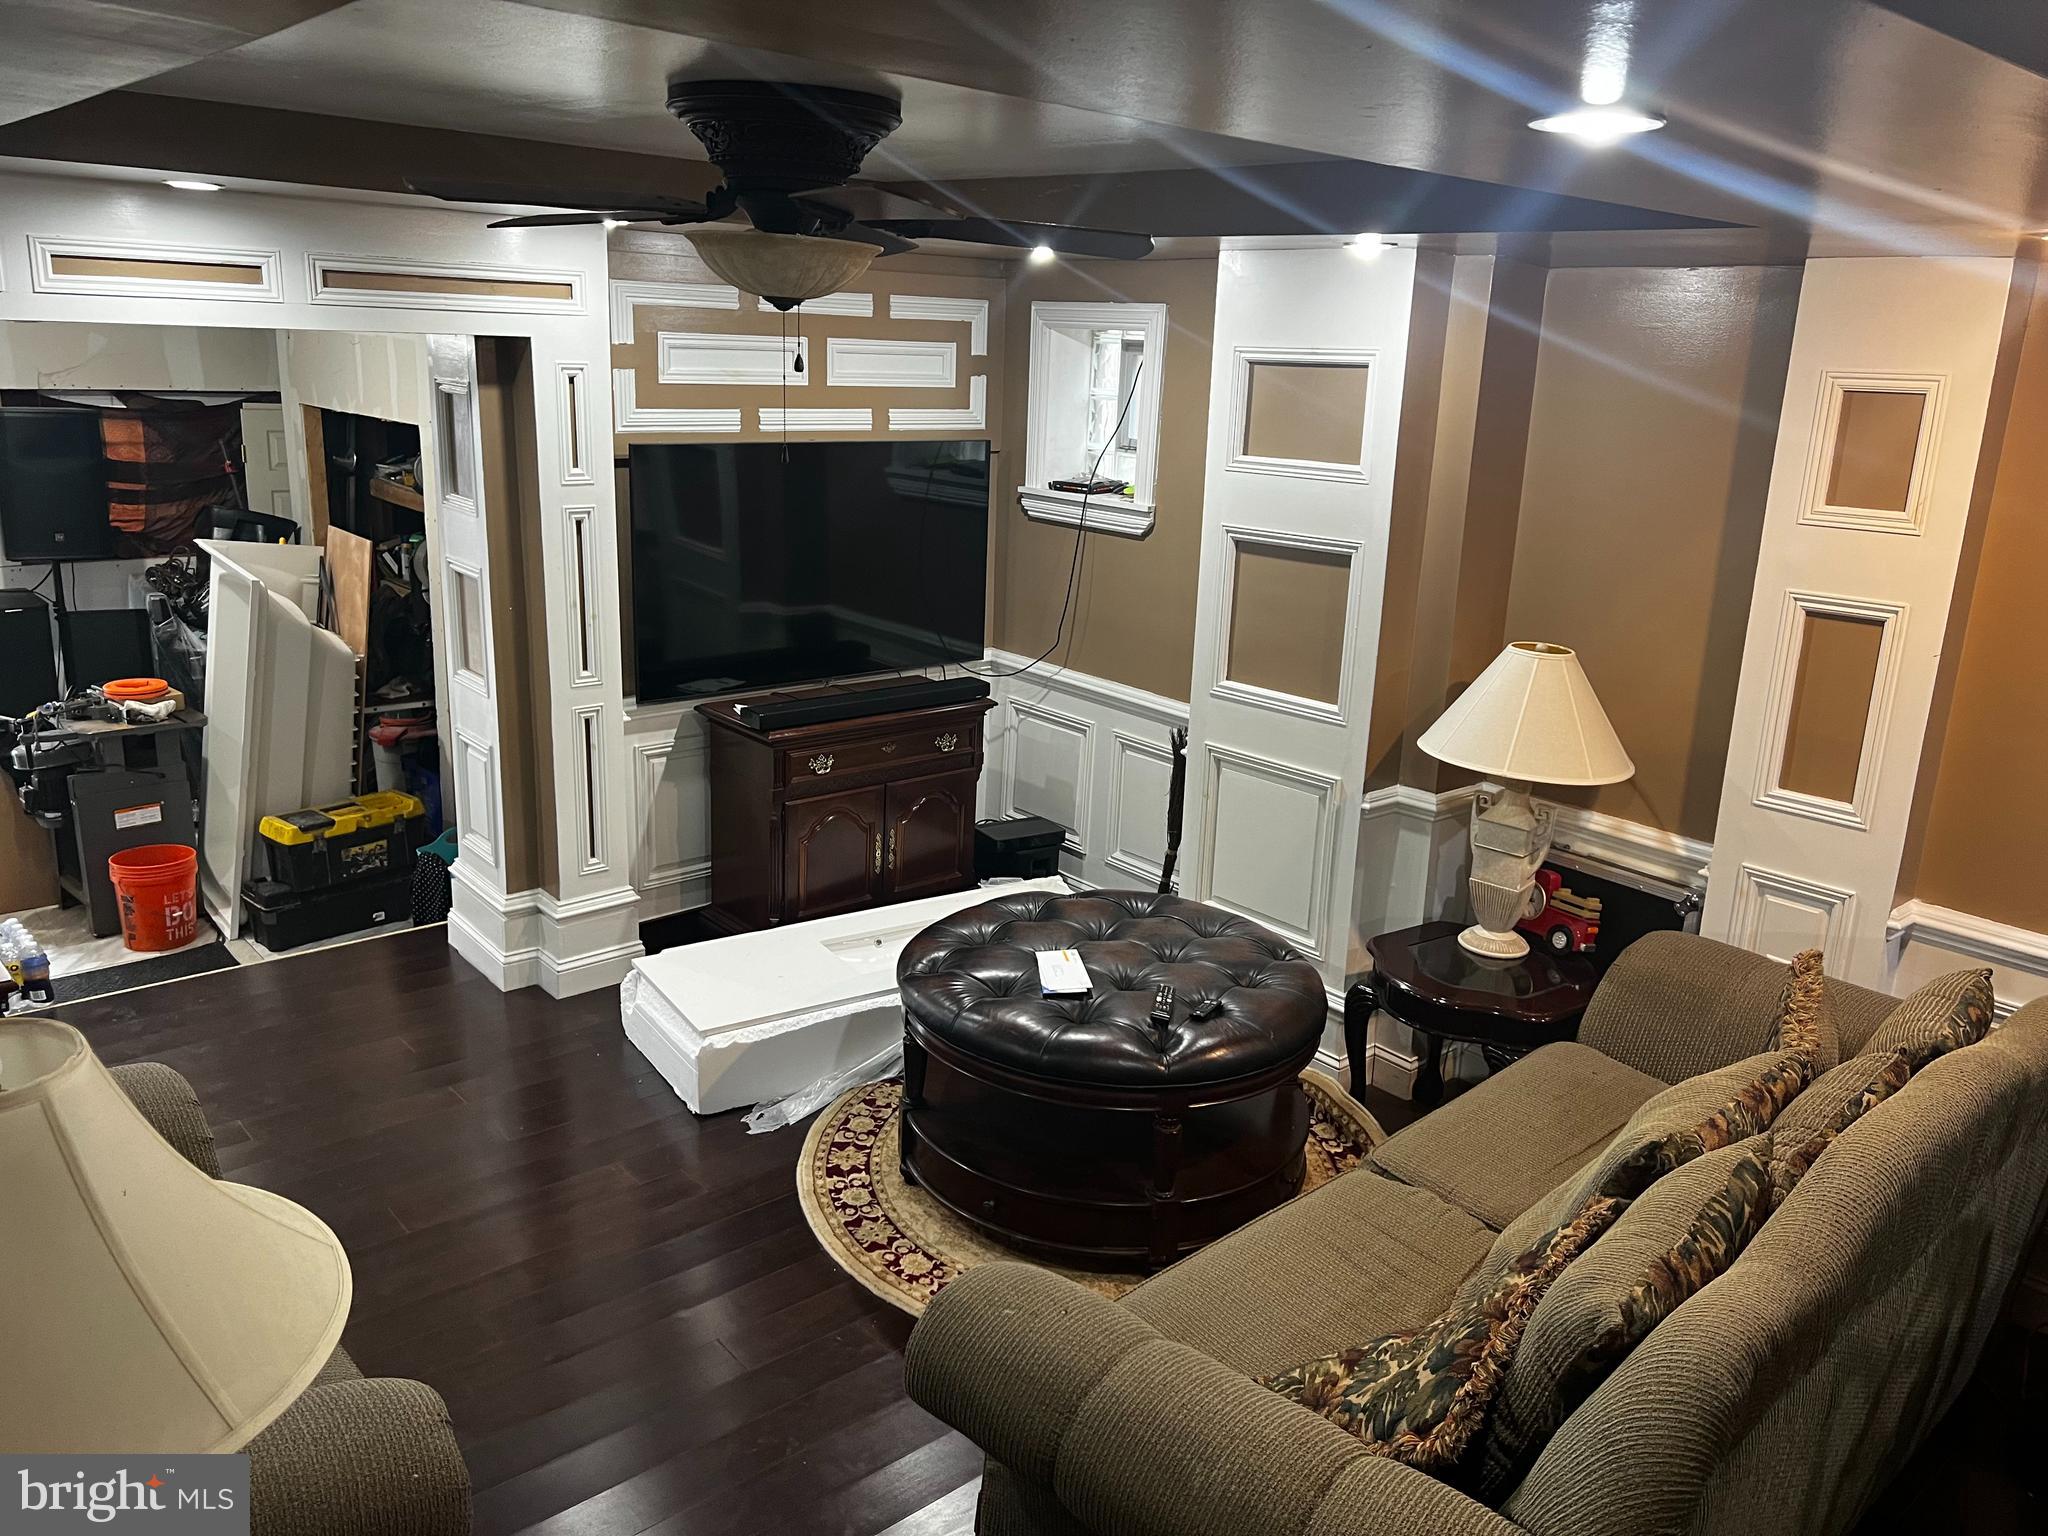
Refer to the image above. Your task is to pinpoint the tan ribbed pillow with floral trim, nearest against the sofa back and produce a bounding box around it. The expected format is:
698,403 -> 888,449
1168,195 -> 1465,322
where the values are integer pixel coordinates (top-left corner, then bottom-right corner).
1479,1137 -> 1769,1499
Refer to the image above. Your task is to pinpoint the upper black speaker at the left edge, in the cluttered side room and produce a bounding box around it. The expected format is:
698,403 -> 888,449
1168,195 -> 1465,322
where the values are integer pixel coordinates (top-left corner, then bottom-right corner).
0,406 -> 115,561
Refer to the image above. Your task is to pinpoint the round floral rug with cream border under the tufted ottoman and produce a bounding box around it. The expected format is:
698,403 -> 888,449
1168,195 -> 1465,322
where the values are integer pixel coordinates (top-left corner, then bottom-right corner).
797,1071 -> 1386,1317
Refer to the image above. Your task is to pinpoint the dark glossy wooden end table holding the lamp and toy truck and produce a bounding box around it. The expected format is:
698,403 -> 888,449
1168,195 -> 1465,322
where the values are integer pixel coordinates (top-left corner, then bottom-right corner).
1343,922 -> 1599,1104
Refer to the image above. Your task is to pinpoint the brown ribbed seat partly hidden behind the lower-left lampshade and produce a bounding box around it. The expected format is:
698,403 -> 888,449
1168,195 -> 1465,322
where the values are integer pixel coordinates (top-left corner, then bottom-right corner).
111,1061 -> 469,1536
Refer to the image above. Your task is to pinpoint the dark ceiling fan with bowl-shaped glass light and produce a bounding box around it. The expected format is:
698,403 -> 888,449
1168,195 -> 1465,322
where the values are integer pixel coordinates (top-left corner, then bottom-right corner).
408,80 -> 1151,309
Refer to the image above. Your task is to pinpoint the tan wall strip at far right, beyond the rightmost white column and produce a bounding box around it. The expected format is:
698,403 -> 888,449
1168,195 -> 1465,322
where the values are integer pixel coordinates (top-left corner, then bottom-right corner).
1901,270 -> 2048,930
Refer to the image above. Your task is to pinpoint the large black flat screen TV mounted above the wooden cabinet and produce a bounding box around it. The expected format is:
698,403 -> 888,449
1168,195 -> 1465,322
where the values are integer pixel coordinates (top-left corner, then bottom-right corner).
627,440 -> 989,702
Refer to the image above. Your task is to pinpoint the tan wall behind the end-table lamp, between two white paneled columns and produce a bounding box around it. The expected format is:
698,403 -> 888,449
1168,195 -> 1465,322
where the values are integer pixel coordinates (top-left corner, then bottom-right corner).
1505,266 -> 1800,840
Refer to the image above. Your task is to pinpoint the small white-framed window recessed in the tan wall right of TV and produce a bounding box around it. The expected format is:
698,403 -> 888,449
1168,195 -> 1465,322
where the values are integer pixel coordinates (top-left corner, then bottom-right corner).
1018,303 -> 1165,539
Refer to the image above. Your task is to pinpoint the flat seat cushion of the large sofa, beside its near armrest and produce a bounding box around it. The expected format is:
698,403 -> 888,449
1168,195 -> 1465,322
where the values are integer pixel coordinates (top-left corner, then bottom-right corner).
1124,1167 -> 1493,1376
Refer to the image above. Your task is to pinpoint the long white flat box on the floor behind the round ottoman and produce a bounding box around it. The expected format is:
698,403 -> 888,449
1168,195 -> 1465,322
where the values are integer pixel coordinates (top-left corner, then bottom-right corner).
618,877 -> 1069,1114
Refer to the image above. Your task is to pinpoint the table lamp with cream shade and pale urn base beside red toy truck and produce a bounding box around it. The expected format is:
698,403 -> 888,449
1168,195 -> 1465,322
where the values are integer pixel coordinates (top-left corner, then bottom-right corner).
1415,641 -> 1636,961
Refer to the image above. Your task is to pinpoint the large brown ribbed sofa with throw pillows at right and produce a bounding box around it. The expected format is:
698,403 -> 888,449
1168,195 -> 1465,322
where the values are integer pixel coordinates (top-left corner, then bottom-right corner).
907,934 -> 2048,1536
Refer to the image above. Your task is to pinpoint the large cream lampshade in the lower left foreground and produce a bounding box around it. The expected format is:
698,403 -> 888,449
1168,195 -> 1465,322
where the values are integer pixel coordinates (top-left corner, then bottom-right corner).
0,1020 -> 350,1452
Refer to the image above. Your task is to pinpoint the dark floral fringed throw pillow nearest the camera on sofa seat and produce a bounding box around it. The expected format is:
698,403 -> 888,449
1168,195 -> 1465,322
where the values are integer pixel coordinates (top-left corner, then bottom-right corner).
1260,1198 -> 1628,1477
